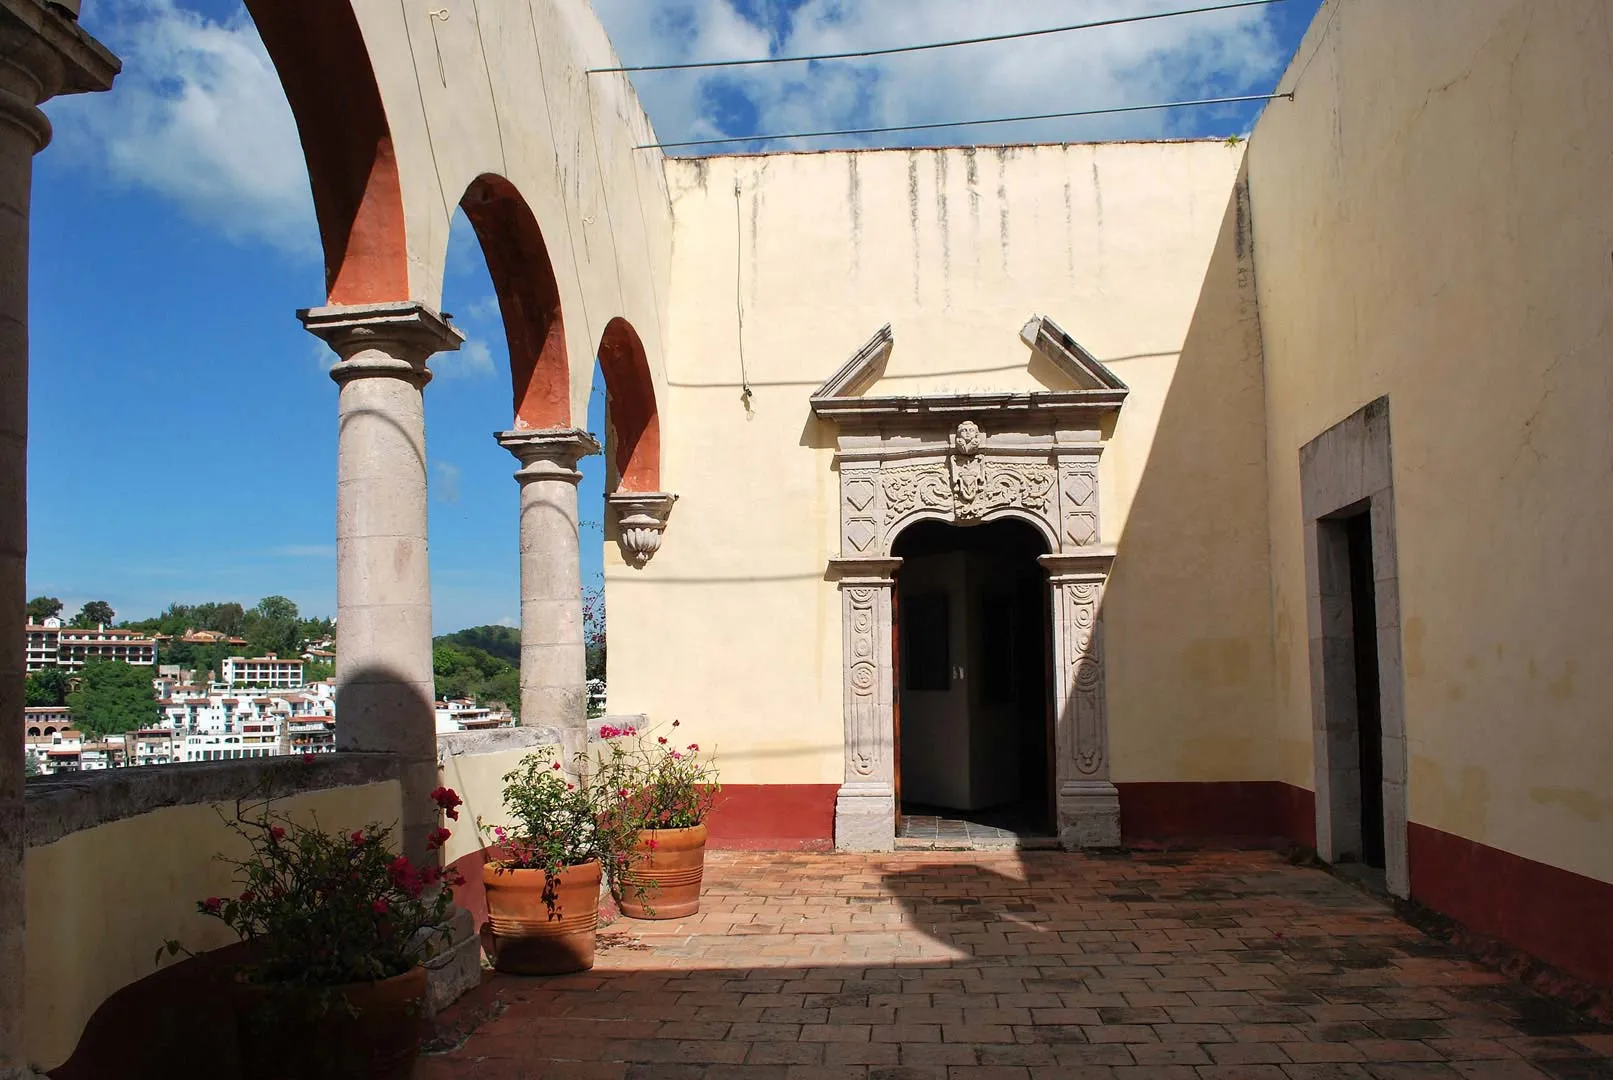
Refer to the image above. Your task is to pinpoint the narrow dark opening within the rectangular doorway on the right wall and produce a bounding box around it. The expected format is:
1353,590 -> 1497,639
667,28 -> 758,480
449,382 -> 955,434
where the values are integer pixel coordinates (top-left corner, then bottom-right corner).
1344,509 -> 1384,870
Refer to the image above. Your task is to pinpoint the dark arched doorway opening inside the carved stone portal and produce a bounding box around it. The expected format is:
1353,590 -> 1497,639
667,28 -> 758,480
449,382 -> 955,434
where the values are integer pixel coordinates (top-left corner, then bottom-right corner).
892,521 -> 1055,843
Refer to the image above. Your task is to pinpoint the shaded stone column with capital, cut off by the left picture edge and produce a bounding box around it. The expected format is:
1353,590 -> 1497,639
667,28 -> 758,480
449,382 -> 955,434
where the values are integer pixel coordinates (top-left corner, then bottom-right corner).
0,0 -> 118,1078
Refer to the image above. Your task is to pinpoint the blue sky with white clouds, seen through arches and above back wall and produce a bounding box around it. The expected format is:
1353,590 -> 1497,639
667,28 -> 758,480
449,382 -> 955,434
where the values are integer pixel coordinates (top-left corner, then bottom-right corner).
27,0 -> 1319,633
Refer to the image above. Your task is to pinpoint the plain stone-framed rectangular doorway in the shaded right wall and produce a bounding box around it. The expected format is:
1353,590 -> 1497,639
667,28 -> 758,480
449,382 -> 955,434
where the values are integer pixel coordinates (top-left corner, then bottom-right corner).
1300,398 -> 1411,896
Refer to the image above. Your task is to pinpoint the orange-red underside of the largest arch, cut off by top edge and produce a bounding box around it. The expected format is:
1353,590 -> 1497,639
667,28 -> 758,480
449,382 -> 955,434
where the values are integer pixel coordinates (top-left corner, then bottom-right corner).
245,0 -> 408,305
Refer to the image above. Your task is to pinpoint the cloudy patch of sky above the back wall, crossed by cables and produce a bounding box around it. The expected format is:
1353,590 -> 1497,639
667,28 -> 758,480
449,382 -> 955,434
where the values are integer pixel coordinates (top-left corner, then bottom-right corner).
595,0 -> 1287,152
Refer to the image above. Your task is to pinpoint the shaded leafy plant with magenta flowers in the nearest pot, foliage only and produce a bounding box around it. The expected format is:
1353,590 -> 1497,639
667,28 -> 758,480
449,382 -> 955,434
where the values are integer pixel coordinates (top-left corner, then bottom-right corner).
158,788 -> 463,987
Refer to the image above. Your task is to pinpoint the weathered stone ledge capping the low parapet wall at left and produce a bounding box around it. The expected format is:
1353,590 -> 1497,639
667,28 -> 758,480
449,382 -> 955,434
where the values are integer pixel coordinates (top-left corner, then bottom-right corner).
24,751 -> 398,848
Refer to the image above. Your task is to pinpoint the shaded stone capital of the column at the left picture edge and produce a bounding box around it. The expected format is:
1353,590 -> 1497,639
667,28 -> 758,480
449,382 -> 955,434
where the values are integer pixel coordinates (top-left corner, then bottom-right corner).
0,0 -> 123,153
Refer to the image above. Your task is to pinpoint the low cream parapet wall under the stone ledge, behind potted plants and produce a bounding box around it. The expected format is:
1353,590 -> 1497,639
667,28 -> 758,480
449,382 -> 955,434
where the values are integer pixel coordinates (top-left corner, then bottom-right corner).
24,780 -> 402,1069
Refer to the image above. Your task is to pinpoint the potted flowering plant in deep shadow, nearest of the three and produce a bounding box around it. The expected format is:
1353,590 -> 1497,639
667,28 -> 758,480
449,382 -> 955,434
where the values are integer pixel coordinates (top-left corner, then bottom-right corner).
158,788 -> 460,1080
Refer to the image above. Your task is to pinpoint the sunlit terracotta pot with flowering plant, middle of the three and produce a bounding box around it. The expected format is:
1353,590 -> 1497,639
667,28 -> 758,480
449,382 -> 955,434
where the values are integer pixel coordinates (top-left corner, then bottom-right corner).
477,751 -> 631,975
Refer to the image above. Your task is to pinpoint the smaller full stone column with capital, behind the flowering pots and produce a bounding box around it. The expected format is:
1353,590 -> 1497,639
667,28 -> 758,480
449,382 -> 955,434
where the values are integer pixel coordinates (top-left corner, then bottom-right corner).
494,427 -> 600,769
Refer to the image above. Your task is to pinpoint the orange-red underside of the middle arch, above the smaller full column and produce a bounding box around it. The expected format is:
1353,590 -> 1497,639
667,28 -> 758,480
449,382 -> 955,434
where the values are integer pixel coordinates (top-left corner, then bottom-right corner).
460,172 -> 571,429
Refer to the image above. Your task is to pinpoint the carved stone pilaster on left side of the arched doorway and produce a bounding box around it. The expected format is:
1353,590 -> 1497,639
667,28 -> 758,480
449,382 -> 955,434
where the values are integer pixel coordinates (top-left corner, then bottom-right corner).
831,558 -> 902,851
